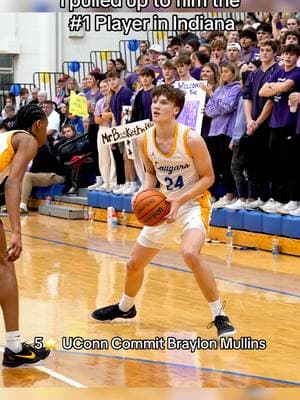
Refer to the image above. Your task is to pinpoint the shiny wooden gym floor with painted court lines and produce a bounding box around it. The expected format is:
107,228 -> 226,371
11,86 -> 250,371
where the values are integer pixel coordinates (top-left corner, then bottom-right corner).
0,213 -> 300,390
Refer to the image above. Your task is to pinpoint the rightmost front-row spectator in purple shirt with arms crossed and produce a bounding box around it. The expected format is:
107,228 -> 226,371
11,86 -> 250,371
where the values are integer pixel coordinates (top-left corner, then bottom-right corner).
259,44 -> 300,214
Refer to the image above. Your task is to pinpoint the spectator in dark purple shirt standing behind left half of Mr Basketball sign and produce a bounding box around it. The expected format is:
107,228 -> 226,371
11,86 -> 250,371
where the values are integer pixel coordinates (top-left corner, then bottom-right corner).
107,71 -> 136,194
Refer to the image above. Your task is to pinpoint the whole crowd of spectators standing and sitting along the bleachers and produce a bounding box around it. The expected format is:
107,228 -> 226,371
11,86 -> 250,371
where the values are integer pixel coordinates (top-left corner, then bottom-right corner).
0,13 -> 300,216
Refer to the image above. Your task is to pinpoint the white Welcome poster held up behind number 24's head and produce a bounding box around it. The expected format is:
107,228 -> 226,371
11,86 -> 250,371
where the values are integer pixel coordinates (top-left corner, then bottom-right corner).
174,81 -> 206,135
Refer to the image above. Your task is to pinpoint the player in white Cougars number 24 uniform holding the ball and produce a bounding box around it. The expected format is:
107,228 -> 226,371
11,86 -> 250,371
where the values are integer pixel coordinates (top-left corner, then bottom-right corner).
92,85 -> 235,337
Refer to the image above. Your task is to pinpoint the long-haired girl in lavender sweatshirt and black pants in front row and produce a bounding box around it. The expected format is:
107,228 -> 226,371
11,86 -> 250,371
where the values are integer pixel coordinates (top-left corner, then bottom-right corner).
205,62 -> 241,208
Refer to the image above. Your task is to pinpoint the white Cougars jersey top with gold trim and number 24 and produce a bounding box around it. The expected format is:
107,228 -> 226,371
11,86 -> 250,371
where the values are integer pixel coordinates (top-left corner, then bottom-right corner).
144,123 -> 199,196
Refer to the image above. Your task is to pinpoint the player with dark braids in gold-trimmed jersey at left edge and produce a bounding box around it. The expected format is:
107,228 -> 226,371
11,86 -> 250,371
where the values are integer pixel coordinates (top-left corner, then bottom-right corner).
0,105 -> 50,367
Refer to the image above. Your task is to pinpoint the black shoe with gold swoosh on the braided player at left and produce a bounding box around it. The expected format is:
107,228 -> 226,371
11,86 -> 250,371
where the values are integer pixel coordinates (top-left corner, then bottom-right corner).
2,343 -> 50,368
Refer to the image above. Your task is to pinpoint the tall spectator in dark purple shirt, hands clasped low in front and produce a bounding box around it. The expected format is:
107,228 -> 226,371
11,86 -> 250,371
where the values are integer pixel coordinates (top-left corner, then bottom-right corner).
243,40 -> 280,210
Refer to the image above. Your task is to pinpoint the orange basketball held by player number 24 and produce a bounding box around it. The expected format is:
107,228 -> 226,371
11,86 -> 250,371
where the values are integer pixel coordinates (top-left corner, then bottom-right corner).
133,189 -> 170,226
